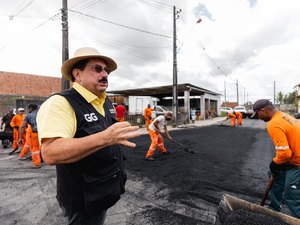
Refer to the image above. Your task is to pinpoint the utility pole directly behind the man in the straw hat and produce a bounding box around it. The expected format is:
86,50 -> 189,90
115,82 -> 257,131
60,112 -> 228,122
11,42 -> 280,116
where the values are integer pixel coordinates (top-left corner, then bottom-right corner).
61,0 -> 70,90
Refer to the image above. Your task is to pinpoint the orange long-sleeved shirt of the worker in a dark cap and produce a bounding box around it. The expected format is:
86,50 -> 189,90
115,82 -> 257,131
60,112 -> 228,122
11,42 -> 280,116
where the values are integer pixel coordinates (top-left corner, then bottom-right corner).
267,112 -> 300,166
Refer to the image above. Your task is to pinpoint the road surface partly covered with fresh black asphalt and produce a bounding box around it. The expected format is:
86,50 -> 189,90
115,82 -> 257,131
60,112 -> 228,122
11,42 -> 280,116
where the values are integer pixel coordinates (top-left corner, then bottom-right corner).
0,119 -> 290,225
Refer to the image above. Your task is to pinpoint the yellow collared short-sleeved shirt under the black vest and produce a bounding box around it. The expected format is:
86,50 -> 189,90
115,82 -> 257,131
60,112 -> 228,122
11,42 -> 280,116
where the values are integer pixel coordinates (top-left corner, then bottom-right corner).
37,82 -> 106,143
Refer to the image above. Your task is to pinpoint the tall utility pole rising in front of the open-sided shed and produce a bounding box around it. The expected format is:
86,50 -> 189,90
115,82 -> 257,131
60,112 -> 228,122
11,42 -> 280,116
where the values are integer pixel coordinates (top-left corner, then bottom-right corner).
172,6 -> 181,127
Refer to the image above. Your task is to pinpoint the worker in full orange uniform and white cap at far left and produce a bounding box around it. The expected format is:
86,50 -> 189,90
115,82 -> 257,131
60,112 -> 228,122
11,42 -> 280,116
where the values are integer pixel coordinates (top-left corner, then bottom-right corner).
10,108 -> 26,154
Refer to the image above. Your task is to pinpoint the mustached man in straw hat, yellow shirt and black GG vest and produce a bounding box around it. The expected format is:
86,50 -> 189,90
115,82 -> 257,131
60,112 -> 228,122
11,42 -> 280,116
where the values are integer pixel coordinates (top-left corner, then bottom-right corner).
37,47 -> 140,225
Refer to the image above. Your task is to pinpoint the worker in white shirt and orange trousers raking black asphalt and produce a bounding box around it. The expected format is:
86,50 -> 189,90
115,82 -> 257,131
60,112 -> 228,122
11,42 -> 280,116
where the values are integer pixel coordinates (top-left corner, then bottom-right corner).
145,112 -> 173,161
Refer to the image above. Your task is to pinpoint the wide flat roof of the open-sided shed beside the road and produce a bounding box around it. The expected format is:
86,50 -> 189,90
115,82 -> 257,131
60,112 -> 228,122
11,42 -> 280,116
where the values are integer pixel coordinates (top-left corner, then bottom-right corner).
106,83 -> 220,98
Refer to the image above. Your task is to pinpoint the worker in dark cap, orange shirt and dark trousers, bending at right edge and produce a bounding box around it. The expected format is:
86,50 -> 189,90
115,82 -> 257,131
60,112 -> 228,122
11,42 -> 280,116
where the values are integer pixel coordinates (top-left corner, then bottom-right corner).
251,99 -> 300,219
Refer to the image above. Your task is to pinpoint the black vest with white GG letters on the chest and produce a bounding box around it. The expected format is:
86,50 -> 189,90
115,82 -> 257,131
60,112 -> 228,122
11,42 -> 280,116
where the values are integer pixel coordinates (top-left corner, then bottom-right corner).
56,88 -> 127,214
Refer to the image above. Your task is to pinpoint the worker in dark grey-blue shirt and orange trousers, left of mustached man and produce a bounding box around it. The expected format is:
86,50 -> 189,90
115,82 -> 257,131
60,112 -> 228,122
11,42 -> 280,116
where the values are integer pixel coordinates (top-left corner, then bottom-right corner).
19,104 -> 42,168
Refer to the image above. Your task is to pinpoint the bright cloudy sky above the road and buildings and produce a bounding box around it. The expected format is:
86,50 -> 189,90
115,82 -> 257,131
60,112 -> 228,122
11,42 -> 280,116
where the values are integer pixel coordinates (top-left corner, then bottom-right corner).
0,0 -> 300,103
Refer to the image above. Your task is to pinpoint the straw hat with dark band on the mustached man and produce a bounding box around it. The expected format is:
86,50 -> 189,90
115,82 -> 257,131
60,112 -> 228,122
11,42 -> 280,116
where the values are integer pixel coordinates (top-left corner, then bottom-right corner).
61,47 -> 117,80
